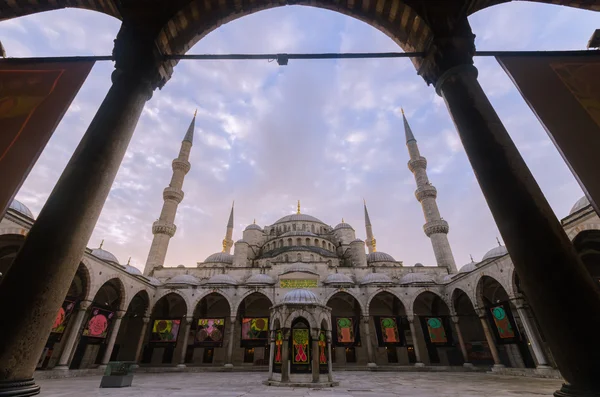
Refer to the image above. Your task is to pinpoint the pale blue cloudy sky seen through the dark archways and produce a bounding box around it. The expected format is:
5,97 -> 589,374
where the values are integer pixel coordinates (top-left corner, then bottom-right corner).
0,2 -> 599,269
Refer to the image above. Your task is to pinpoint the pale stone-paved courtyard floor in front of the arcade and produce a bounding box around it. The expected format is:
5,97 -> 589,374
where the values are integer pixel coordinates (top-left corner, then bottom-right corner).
38,372 -> 561,397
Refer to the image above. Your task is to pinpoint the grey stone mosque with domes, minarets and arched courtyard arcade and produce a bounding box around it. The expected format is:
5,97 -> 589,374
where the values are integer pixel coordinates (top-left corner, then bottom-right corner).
0,110 -> 600,384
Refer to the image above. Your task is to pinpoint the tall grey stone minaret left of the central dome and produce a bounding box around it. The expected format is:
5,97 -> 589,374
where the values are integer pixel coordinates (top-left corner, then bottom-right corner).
144,112 -> 196,276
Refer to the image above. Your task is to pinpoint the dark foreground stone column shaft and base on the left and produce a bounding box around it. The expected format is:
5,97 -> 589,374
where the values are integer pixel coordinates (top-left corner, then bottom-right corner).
0,64 -> 152,396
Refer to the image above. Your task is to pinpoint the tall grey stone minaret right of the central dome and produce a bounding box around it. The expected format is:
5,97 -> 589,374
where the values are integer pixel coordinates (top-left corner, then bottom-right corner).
402,110 -> 456,273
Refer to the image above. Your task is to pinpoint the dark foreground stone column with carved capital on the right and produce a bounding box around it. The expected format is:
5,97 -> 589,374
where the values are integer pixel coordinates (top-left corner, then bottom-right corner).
421,20 -> 600,396
